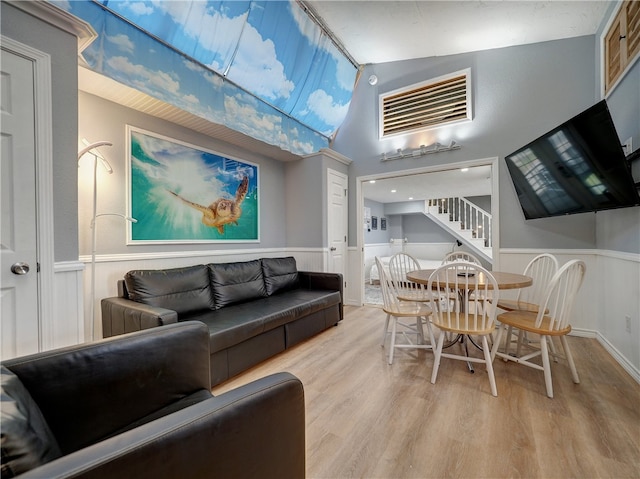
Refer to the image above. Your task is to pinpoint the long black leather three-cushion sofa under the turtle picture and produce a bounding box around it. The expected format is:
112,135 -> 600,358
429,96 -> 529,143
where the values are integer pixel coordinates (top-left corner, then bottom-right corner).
101,257 -> 343,385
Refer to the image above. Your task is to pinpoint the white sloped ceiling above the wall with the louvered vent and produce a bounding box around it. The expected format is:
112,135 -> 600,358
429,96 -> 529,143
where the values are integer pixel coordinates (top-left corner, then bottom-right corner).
303,0 -> 610,65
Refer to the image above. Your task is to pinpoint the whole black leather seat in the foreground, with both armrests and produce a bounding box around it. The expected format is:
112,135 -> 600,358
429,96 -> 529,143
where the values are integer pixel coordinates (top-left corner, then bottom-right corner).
2,321 -> 305,479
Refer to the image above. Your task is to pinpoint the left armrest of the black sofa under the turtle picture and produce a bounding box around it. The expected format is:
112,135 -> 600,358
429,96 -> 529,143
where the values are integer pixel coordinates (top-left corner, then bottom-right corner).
100,297 -> 178,338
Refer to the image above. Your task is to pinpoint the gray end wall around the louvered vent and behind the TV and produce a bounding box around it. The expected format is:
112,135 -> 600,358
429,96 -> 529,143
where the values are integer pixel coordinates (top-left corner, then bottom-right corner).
332,35 -> 638,251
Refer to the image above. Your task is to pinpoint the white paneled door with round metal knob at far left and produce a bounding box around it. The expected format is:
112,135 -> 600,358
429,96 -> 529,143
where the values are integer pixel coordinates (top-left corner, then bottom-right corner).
0,50 -> 40,359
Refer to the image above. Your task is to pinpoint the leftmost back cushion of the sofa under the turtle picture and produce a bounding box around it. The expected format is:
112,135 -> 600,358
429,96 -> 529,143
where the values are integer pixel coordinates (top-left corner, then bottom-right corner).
124,264 -> 213,315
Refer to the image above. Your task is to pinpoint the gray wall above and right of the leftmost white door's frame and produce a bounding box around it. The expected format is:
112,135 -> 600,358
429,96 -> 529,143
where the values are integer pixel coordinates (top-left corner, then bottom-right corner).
0,2 -> 78,262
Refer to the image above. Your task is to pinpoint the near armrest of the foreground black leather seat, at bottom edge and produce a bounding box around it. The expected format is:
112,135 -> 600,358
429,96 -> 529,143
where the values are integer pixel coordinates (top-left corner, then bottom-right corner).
21,373 -> 305,479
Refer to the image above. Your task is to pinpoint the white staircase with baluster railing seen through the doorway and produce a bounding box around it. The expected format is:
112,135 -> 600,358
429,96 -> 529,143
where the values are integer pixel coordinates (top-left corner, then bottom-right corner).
424,198 -> 493,263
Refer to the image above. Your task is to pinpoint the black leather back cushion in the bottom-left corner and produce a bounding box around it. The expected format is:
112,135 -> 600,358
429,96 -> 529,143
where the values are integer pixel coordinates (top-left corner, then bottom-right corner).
0,366 -> 61,478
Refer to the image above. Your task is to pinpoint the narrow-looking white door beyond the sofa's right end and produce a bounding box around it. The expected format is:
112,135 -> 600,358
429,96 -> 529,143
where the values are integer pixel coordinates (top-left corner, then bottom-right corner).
327,169 -> 348,284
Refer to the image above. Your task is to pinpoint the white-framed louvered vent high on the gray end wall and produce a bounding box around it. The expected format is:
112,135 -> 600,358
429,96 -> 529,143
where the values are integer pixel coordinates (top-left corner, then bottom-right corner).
380,69 -> 472,138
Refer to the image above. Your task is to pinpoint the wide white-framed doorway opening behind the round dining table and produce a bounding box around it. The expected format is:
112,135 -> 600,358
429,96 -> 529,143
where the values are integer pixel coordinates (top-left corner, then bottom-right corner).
356,157 -> 499,305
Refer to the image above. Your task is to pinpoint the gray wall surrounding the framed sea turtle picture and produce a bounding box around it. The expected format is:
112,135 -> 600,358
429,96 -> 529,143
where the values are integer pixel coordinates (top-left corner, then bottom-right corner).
80,92 -> 288,254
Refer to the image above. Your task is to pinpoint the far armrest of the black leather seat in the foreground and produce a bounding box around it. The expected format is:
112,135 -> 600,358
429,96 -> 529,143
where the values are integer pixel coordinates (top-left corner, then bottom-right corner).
2,321 -> 211,454
